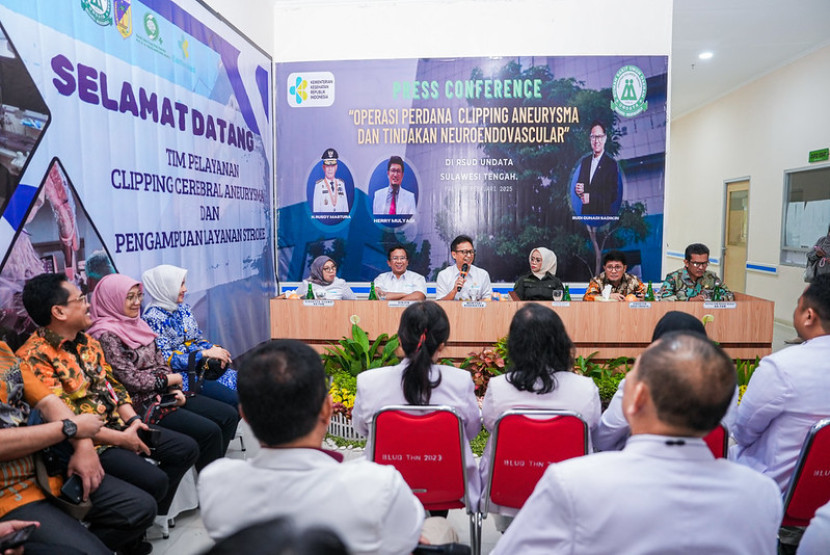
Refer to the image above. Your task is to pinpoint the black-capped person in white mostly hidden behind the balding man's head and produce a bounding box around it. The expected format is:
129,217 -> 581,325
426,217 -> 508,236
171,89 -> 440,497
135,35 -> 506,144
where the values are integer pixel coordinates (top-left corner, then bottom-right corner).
593,310 -> 738,451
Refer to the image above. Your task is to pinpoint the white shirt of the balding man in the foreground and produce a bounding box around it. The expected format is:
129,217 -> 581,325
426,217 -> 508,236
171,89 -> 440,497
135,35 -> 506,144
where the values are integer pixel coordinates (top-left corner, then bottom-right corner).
492,435 -> 782,555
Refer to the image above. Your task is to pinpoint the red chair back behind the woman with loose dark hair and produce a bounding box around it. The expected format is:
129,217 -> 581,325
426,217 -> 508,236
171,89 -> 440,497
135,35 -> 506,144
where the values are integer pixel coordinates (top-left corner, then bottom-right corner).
484,410 -> 588,513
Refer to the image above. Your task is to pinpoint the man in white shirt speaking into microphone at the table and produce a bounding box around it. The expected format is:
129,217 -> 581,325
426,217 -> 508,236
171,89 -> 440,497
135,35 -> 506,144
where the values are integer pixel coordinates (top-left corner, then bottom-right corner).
435,235 -> 493,301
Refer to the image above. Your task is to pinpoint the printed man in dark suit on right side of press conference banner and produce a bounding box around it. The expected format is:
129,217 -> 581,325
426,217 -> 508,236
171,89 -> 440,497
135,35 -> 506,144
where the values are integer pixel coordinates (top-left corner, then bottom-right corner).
574,120 -> 620,216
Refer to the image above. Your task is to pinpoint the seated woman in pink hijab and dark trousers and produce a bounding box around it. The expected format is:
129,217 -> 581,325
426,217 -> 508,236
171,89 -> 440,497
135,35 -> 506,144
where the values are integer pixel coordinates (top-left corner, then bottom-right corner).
87,274 -> 239,470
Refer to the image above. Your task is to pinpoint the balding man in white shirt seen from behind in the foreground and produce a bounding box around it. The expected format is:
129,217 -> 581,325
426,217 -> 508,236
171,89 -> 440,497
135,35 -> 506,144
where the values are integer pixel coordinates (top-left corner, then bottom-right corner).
493,332 -> 782,555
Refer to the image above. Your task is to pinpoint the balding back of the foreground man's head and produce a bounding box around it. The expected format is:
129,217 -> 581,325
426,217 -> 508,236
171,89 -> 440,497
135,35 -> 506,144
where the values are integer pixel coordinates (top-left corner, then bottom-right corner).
637,331 -> 737,436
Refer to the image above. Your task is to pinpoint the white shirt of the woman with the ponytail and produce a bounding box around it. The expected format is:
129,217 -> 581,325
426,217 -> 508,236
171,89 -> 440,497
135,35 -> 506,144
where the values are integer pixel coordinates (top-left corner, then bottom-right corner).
352,359 -> 481,507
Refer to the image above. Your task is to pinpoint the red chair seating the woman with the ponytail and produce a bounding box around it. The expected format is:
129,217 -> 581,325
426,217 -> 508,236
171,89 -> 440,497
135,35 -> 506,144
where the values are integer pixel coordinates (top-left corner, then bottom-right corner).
371,405 -> 481,554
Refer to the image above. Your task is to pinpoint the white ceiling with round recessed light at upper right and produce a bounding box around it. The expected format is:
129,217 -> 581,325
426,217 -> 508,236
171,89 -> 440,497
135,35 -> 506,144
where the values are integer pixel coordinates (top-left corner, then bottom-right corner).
671,0 -> 830,119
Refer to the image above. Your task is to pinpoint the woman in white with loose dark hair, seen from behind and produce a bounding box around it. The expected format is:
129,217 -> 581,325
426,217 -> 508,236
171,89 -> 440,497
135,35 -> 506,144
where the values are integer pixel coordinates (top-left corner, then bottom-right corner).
481,304 -> 600,530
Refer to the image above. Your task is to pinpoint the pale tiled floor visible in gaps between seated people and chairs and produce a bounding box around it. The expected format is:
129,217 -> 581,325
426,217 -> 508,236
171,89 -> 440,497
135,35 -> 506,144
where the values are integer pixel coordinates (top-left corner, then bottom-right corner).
150,323 -> 795,555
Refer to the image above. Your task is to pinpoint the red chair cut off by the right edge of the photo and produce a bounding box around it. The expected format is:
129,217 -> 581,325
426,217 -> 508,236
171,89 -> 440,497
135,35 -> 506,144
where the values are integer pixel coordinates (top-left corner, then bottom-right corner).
781,418 -> 830,526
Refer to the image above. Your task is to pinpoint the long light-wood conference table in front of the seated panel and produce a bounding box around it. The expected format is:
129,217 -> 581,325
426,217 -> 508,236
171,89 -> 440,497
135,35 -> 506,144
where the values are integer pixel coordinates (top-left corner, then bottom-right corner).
271,293 -> 774,359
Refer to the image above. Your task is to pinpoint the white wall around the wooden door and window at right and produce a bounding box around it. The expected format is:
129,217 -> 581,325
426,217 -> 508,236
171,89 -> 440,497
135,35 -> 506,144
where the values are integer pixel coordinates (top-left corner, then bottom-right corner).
663,47 -> 830,323
